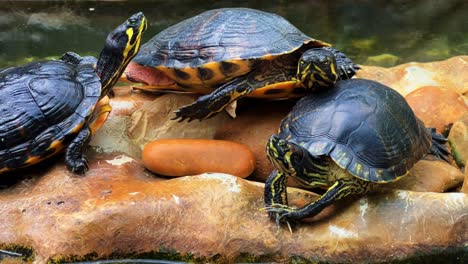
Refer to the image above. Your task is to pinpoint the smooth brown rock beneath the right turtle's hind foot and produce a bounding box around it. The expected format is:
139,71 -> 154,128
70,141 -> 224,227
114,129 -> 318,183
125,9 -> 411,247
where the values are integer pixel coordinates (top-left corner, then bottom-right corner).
382,160 -> 464,193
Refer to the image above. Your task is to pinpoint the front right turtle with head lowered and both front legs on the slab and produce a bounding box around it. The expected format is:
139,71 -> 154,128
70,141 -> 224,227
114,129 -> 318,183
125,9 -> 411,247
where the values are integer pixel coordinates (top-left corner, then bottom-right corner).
264,78 -> 451,224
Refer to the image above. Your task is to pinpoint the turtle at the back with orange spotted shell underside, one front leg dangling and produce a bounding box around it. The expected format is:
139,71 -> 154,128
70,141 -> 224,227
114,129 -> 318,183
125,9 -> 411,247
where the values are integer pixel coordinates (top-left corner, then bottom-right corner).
123,8 -> 360,121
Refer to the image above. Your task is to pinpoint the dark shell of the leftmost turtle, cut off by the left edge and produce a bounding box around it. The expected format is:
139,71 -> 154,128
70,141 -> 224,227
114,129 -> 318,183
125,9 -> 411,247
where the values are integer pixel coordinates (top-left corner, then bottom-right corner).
0,57 -> 101,172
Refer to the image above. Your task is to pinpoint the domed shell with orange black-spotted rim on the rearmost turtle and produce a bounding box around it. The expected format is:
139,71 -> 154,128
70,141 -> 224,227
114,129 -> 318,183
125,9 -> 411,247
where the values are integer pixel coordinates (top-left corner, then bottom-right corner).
133,8 -> 330,86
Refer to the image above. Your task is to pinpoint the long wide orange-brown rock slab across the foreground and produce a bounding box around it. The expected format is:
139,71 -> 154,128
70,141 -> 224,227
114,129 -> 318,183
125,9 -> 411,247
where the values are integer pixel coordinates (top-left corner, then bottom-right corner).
0,155 -> 468,263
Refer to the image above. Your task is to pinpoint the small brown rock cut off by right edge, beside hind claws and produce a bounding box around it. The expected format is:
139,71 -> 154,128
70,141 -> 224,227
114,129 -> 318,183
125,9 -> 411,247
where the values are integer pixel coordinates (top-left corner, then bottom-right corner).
448,114 -> 468,167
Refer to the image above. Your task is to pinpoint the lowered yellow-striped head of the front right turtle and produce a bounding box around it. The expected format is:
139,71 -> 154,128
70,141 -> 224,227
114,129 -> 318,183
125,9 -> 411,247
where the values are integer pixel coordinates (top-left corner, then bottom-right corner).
266,135 -> 304,175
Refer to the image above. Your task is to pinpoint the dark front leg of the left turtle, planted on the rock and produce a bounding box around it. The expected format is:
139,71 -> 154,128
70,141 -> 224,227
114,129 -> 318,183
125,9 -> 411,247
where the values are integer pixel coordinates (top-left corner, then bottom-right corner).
65,125 -> 91,174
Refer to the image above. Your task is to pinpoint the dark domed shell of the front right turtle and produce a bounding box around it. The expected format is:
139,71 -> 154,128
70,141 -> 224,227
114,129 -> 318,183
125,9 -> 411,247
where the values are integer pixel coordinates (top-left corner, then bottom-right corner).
279,79 -> 431,182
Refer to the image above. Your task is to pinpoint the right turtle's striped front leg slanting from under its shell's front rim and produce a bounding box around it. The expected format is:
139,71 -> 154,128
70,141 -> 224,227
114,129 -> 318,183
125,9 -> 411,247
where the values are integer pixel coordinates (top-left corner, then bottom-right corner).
270,177 -> 371,222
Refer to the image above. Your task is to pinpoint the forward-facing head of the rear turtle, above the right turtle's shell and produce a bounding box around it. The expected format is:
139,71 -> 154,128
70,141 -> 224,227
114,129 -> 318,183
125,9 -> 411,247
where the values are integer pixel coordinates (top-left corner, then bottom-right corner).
297,48 -> 339,91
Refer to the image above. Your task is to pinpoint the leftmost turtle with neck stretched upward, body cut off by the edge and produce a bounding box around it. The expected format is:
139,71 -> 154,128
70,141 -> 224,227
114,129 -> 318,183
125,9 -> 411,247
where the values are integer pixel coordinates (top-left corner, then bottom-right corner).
0,12 -> 147,174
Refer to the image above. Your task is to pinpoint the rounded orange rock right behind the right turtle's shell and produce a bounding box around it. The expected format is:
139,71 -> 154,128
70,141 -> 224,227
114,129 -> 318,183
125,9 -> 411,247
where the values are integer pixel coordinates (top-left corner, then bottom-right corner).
405,86 -> 468,133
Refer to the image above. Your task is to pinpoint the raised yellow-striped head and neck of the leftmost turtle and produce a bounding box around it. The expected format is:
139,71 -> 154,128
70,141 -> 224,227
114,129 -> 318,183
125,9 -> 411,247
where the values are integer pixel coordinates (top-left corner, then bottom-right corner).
96,12 -> 147,97
